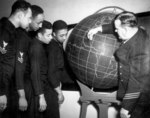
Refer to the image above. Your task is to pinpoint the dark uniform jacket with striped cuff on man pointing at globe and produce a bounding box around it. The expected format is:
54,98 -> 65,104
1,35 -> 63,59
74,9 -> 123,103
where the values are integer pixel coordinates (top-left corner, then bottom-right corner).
116,28 -> 150,112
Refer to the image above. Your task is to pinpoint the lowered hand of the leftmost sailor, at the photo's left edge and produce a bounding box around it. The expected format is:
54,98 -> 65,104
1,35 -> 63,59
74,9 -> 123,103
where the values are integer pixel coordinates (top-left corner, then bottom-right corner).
0,95 -> 7,111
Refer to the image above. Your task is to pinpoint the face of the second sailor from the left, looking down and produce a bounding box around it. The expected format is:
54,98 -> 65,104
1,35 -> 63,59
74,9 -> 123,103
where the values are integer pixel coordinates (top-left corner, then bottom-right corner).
30,14 -> 44,31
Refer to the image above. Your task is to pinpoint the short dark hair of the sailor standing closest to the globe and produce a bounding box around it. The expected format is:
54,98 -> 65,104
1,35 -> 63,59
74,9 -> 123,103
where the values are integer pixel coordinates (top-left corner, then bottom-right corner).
53,20 -> 68,32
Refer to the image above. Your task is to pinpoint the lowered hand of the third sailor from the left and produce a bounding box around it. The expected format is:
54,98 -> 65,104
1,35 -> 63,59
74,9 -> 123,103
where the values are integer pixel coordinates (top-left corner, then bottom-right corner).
39,94 -> 47,112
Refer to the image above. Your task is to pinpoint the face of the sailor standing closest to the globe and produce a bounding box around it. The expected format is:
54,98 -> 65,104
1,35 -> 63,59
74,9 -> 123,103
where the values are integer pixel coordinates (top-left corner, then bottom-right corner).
54,29 -> 68,43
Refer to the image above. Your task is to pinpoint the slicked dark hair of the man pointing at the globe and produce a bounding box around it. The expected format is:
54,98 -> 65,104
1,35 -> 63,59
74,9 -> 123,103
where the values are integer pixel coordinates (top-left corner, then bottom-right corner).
115,11 -> 138,27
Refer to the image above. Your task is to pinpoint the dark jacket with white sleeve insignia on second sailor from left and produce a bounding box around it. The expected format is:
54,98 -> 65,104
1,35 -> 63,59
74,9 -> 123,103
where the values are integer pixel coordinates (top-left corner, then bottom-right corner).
15,28 -> 31,90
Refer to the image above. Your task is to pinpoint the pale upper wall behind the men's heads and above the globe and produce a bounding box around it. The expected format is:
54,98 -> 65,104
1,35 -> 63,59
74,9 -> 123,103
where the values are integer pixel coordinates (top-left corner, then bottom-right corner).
27,0 -> 150,24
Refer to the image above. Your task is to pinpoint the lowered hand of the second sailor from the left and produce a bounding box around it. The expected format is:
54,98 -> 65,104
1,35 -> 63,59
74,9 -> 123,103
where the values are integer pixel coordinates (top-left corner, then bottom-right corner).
19,97 -> 28,111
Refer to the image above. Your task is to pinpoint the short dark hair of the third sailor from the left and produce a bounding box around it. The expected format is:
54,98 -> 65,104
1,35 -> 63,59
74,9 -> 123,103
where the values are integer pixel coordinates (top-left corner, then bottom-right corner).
37,20 -> 52,34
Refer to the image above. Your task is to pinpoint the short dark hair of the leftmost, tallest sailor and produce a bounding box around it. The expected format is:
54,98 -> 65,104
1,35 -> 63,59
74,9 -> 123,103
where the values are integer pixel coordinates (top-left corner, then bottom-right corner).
11,0 -> 31,14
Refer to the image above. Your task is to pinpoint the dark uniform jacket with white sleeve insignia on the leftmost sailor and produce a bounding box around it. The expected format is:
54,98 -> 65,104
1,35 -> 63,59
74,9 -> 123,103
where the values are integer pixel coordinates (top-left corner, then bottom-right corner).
0,18 -> 16,95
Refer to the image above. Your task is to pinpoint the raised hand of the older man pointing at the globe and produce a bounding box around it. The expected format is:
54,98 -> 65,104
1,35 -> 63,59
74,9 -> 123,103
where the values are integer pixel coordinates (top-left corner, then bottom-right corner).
87,26 -> 102,40
